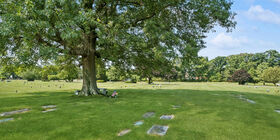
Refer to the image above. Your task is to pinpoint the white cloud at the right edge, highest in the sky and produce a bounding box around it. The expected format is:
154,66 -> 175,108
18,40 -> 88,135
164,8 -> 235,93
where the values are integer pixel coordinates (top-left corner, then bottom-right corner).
246,5 -> 280,25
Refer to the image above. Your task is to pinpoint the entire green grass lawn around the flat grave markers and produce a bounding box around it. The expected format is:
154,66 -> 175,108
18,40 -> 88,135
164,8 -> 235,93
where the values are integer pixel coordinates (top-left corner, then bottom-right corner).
0,81 -> 280,140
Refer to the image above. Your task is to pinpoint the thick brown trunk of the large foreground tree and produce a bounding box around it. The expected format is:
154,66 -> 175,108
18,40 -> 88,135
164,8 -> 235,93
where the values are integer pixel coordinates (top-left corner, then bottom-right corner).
80,53 -> 99,96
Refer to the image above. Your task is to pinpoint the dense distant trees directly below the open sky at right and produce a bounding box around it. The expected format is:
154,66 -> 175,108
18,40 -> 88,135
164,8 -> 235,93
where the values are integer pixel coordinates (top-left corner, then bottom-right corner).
181,50 -> 280,84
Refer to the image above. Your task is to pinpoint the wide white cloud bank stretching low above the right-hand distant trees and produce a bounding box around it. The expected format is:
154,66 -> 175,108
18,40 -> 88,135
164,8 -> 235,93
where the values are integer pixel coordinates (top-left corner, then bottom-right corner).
199,32 -> 280,59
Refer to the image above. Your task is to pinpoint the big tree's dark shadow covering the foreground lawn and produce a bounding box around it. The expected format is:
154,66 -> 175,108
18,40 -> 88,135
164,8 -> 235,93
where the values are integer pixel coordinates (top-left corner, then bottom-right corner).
0,89 -> 280,139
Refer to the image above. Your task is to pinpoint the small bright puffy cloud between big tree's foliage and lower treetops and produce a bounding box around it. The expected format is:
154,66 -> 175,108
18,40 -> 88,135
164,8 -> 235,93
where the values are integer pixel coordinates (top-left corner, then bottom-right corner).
209,33 -> 249,49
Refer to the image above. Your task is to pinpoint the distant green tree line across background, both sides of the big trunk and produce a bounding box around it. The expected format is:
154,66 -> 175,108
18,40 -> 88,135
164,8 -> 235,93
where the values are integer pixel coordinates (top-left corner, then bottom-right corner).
0,50 -> 280,84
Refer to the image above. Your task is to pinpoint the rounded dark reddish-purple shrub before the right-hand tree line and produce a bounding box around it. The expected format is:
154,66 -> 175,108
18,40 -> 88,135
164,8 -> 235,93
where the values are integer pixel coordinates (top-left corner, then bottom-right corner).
231,69 -> 251,85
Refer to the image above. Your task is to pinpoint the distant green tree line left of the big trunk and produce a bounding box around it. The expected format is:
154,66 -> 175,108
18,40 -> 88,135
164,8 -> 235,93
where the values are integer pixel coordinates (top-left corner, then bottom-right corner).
0,57 -> 82,82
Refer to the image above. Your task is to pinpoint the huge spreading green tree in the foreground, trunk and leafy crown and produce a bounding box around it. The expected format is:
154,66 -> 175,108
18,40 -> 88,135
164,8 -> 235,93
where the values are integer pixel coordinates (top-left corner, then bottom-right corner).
0,0 -> 235,96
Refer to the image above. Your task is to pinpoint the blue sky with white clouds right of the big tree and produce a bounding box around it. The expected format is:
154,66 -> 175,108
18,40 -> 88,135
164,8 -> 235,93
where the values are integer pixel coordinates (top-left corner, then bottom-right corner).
199,0 -> 280,59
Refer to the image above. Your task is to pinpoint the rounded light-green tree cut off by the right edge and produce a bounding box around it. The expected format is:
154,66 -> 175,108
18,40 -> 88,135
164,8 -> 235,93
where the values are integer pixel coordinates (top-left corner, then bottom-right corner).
262,66 -> 280,85
